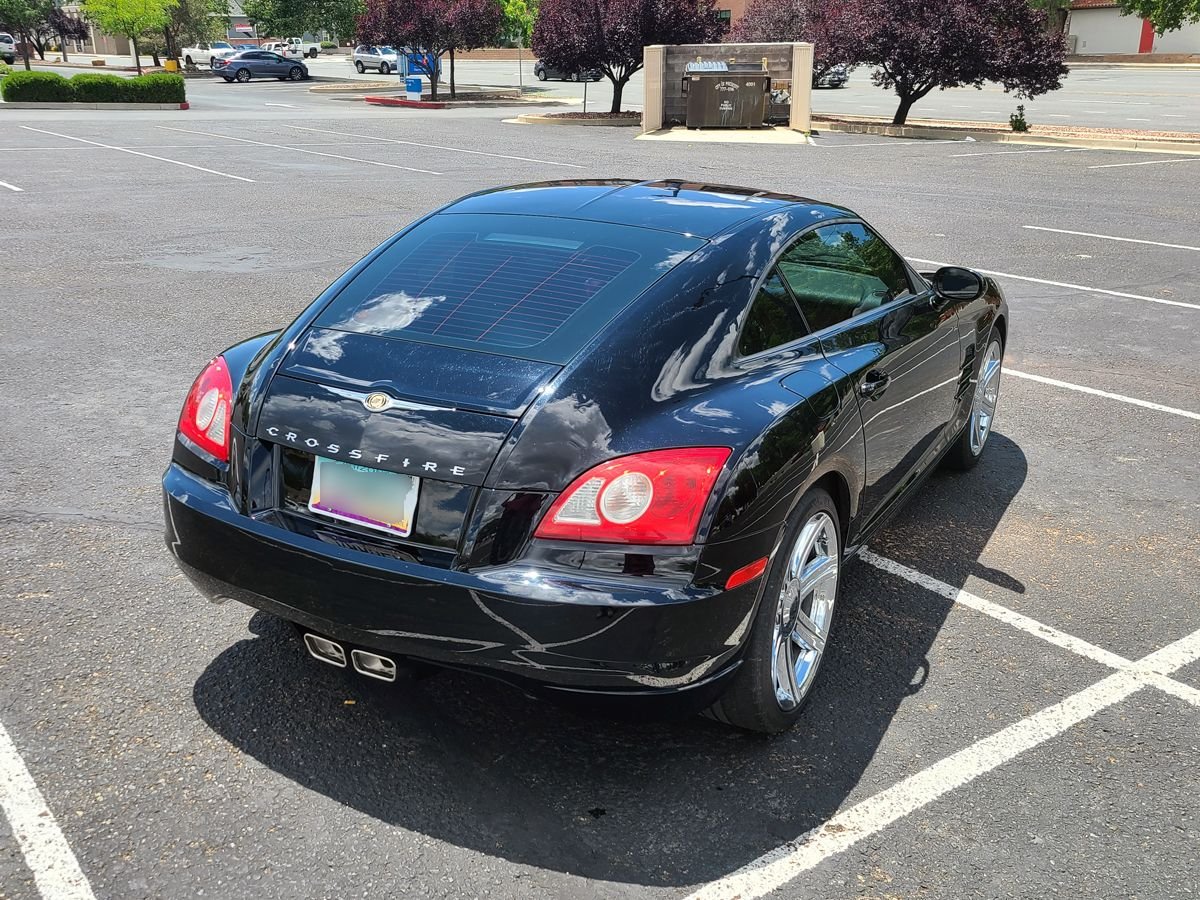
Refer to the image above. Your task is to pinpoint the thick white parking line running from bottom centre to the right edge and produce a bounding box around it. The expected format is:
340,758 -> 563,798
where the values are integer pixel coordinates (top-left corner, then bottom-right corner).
686,588 -> 1200,900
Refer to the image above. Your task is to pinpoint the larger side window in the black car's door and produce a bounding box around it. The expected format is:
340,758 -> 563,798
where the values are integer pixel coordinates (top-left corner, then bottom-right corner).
779,224 -> 911,331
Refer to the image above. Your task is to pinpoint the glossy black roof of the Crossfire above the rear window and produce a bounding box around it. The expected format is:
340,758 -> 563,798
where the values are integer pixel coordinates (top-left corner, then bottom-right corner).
442,179 -> 854,238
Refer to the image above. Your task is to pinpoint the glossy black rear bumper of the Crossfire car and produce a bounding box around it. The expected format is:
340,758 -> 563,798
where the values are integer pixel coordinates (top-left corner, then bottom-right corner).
163,463 -> 757,704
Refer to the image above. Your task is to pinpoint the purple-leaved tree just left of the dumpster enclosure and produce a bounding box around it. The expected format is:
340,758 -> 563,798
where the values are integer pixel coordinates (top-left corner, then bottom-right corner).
533,0 -> 725,113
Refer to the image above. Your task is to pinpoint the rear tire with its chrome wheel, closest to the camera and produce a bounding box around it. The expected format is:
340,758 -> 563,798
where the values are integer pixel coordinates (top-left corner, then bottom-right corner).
709,487 -> 842,734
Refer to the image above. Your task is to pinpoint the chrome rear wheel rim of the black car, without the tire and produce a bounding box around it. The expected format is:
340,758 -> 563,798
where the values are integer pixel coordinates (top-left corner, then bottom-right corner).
770,512 -> 841,712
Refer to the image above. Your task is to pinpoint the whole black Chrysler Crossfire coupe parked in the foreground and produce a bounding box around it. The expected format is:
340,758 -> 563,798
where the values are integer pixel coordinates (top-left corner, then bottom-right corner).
163,181 -> 1008,732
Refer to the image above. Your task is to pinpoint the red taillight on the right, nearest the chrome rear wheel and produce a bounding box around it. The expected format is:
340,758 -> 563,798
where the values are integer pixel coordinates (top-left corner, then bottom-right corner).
535,446 -> 730,544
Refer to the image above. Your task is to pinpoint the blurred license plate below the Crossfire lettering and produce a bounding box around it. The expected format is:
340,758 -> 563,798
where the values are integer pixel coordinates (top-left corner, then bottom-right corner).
308,456 -> 421,538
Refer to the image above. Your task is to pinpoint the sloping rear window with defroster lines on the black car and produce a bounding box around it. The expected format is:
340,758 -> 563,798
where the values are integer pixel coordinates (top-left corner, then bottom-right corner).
316,214 -> 704,364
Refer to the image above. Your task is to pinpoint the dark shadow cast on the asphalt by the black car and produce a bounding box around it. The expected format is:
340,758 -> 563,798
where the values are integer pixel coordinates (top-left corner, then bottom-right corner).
193,433 -> 1026,887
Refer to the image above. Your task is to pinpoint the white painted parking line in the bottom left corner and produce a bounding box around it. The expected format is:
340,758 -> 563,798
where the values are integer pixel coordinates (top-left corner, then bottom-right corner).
0,725 -> 96,900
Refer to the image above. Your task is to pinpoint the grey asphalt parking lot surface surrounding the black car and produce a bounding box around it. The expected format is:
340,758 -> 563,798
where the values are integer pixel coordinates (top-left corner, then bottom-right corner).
0,100 -> 1200,900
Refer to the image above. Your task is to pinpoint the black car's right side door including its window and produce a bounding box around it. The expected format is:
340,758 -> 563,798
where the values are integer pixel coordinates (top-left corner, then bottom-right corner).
779,222 -> 962,529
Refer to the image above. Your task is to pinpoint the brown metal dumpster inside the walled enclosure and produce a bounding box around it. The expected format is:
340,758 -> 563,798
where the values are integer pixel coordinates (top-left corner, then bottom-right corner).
683,60 -> 770,128
